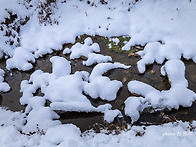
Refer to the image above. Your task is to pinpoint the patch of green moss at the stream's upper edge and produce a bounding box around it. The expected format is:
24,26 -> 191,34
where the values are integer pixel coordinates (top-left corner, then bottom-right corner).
107,36 -> 136,54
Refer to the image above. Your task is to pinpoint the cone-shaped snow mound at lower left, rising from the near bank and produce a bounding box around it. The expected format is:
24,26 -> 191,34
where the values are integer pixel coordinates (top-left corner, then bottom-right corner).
22,96 -> 60,133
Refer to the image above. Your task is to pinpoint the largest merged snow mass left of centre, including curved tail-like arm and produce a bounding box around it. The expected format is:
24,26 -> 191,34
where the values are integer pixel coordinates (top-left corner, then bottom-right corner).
20,56 -> 125,132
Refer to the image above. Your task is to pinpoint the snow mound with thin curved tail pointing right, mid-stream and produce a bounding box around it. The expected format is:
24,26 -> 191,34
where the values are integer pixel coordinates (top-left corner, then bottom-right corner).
84,63 -> 131,101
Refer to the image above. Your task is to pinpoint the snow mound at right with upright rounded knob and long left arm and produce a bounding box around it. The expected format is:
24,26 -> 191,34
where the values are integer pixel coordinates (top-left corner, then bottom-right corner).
125,59 -> 196,122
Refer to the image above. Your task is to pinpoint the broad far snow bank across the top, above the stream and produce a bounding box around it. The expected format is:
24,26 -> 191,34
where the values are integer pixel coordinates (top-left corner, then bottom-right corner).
1,0 -> 196,73
